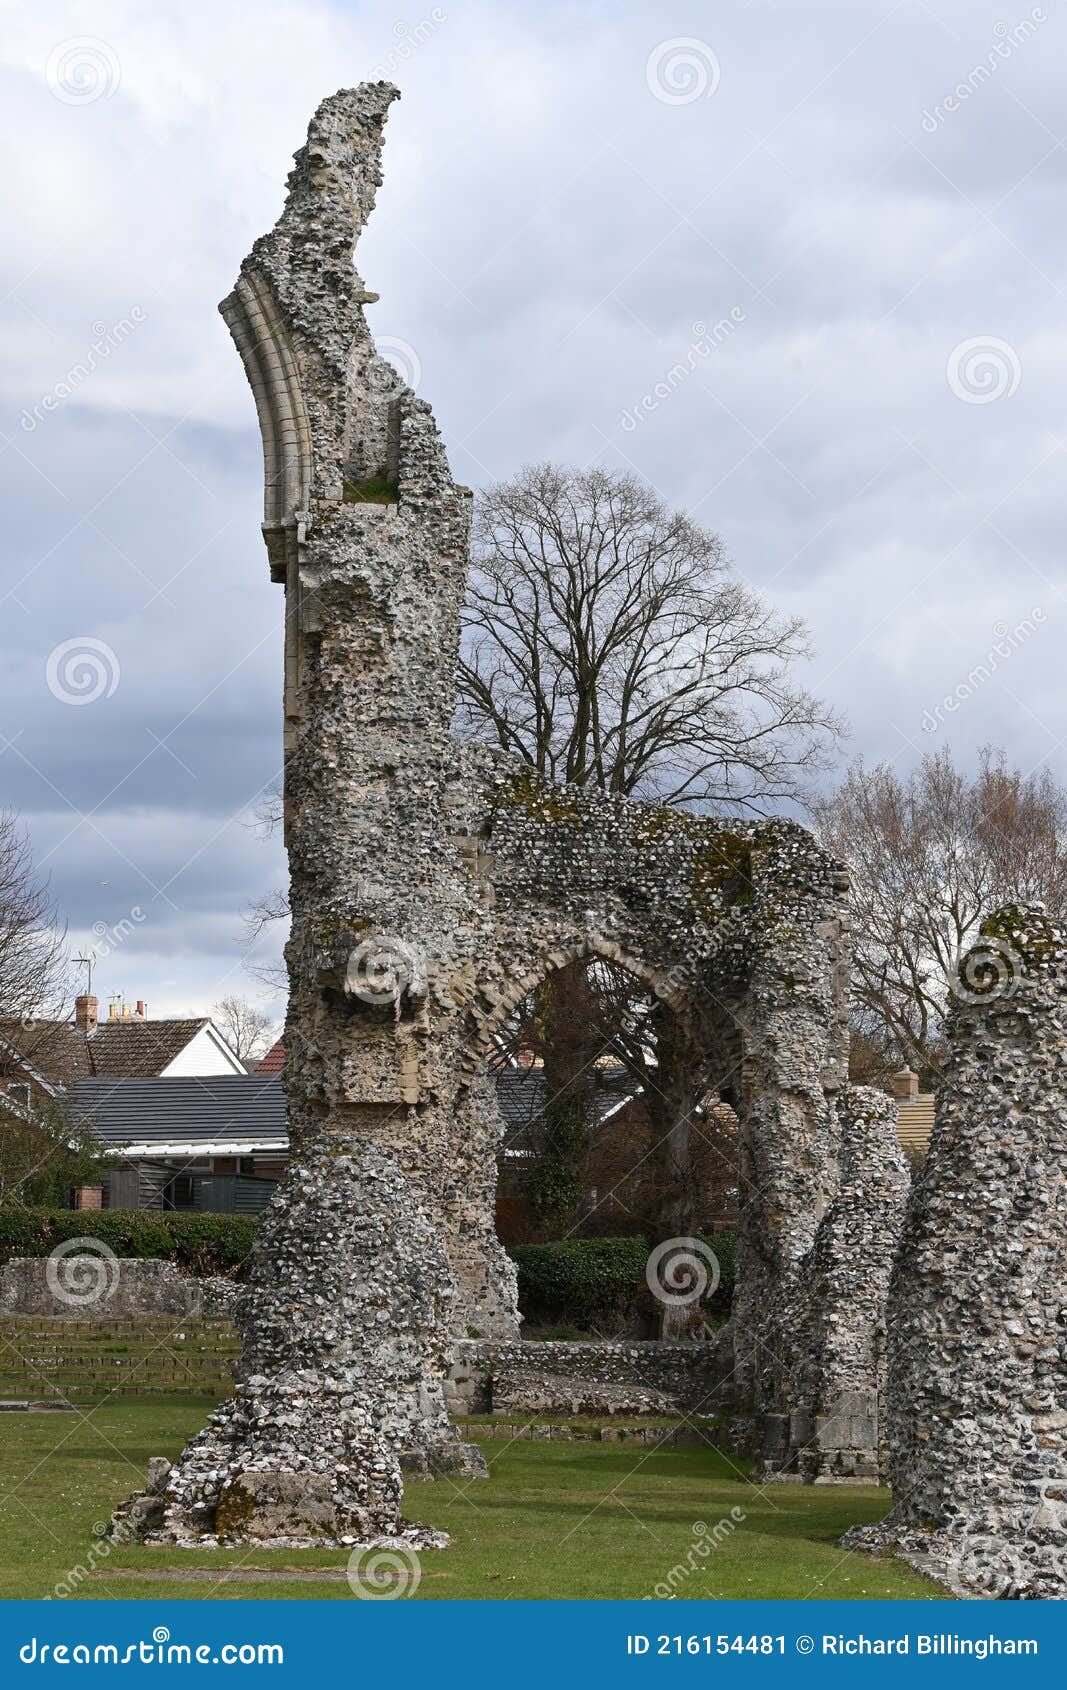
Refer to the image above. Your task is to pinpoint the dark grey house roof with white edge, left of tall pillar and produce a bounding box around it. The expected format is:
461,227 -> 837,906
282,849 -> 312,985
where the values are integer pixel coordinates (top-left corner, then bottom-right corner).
66,1073 -> 289,1154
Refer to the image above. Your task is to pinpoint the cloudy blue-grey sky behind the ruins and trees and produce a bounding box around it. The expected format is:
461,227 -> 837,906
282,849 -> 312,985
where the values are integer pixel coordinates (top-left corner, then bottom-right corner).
0,0 -> 1067,1012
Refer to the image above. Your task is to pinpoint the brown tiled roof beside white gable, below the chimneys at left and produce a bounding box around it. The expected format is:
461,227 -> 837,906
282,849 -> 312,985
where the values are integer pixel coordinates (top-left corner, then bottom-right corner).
0,1016 -> 228,1087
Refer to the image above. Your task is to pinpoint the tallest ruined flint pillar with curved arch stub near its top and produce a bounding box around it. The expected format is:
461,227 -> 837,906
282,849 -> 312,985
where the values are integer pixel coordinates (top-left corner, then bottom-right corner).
110,83 -> 485,1543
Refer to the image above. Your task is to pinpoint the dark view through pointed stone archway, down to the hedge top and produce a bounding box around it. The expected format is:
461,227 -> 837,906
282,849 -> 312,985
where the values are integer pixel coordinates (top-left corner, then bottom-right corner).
484,951 -> 741,1270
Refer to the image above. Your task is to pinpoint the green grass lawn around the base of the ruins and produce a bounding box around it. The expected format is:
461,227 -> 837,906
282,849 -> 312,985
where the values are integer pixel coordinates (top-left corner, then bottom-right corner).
0,1398 -> 942,1600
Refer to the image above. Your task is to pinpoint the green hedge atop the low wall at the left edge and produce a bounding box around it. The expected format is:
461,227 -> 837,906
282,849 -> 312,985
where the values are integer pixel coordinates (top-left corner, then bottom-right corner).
0,1208 -> 255,1279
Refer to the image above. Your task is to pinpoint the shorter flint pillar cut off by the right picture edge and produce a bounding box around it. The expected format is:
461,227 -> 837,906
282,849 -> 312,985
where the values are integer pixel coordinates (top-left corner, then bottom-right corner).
847,908 -> 1067,1597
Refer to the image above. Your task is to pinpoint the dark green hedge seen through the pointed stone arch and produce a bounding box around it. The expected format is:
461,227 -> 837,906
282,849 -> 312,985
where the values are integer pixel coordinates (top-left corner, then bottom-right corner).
511,1232 -> 734,1327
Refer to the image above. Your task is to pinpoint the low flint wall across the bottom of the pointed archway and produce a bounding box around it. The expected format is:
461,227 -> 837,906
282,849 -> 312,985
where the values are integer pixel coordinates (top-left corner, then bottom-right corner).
445,1327 -> 734,1415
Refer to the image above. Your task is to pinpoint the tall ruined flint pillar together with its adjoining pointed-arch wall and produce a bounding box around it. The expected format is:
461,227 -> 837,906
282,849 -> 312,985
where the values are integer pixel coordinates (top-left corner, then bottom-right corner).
123,83 -> 886,1541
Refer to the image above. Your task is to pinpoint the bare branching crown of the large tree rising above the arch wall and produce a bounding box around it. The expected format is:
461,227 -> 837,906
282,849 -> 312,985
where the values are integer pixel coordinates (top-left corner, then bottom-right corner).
457,463 -> 840,811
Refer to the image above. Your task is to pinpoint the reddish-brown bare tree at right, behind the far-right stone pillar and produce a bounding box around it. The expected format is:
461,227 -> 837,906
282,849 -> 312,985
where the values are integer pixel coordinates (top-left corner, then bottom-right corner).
813,747 -> 1067,1070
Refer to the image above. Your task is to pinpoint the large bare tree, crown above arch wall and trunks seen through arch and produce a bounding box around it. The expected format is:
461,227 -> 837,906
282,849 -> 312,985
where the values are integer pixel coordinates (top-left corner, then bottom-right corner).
457,463 -> 840,1225
